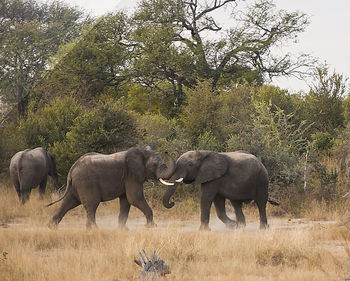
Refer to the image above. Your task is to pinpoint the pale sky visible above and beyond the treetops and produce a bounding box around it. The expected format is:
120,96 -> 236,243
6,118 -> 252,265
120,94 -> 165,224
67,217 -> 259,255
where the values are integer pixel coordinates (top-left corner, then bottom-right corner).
58,0 -> 350,92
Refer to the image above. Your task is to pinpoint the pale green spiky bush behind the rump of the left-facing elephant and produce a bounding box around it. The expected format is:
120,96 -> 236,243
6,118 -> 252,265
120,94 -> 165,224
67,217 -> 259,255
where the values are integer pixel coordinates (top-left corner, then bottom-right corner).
227,102 -> 307,185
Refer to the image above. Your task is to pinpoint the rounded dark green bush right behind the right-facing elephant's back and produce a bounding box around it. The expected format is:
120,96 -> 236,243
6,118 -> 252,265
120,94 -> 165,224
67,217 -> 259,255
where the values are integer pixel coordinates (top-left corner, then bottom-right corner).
51,98 -> 138,173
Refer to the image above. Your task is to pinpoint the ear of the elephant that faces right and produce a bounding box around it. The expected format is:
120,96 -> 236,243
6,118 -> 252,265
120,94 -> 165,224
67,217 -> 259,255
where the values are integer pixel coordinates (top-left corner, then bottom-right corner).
125,148 -> 146,183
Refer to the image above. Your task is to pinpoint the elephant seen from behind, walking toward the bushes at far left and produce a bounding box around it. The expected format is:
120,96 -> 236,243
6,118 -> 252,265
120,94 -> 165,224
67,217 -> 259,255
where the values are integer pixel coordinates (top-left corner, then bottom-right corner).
10,147 -> 58,204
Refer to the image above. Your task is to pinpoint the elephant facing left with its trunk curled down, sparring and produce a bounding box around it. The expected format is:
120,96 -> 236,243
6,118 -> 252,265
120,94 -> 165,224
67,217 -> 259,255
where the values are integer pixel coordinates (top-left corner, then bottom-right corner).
163,150 -> 268,229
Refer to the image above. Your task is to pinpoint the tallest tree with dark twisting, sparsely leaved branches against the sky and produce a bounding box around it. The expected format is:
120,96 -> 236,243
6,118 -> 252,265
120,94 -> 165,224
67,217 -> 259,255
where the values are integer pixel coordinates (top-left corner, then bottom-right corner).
133,0 -> 312,103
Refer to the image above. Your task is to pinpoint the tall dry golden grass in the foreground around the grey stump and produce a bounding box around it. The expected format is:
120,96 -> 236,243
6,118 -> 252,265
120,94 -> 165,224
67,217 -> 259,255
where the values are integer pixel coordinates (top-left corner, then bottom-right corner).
0,225 -> 350,281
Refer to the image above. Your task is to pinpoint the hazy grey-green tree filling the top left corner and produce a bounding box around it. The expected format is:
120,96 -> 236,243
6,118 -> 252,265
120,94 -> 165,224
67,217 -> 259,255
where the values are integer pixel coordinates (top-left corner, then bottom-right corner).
0,0 -> 89,117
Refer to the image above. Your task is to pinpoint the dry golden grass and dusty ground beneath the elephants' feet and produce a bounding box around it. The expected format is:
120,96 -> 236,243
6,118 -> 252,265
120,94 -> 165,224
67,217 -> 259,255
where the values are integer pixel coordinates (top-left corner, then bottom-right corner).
0,179 -> 350,281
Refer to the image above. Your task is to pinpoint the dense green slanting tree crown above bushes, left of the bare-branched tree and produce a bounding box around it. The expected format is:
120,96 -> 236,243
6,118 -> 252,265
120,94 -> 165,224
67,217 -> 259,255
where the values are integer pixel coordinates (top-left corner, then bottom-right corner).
39,12 -> 132,103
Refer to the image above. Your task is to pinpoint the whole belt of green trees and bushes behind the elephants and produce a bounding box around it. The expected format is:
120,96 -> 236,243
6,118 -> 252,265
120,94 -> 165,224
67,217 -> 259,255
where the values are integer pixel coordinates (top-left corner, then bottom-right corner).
0,0 -> 350,211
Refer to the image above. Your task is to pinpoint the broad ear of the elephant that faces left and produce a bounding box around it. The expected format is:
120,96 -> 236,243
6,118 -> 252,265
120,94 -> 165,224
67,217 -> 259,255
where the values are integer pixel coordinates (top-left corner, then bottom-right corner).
195,151 -> 228,184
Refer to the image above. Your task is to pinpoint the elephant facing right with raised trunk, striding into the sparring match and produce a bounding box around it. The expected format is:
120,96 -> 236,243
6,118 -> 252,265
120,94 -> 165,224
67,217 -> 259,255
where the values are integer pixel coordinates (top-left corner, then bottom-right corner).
49,148 -> 175,228
